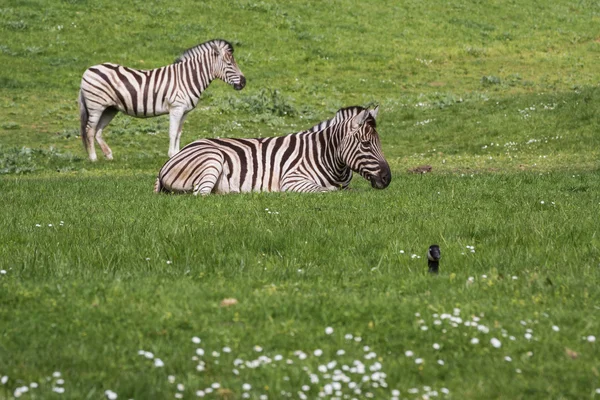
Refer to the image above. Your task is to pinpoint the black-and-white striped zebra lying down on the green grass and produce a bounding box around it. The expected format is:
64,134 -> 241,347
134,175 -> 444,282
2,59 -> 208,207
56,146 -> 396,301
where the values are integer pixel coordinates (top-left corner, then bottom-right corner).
154,107 -> 392,195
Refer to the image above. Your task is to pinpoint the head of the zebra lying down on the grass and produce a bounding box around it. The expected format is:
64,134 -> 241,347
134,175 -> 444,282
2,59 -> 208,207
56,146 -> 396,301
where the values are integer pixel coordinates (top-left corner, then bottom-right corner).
340,106 -> 392,189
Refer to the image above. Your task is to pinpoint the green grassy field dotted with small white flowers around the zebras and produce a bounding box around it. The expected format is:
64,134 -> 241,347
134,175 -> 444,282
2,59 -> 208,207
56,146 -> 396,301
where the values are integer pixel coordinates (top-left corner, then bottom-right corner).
0,0 -> 600,400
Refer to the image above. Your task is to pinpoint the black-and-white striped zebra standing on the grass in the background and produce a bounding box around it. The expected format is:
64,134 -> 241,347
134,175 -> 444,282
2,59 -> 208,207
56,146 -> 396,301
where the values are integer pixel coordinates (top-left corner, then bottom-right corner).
79,39 -> 246,161
